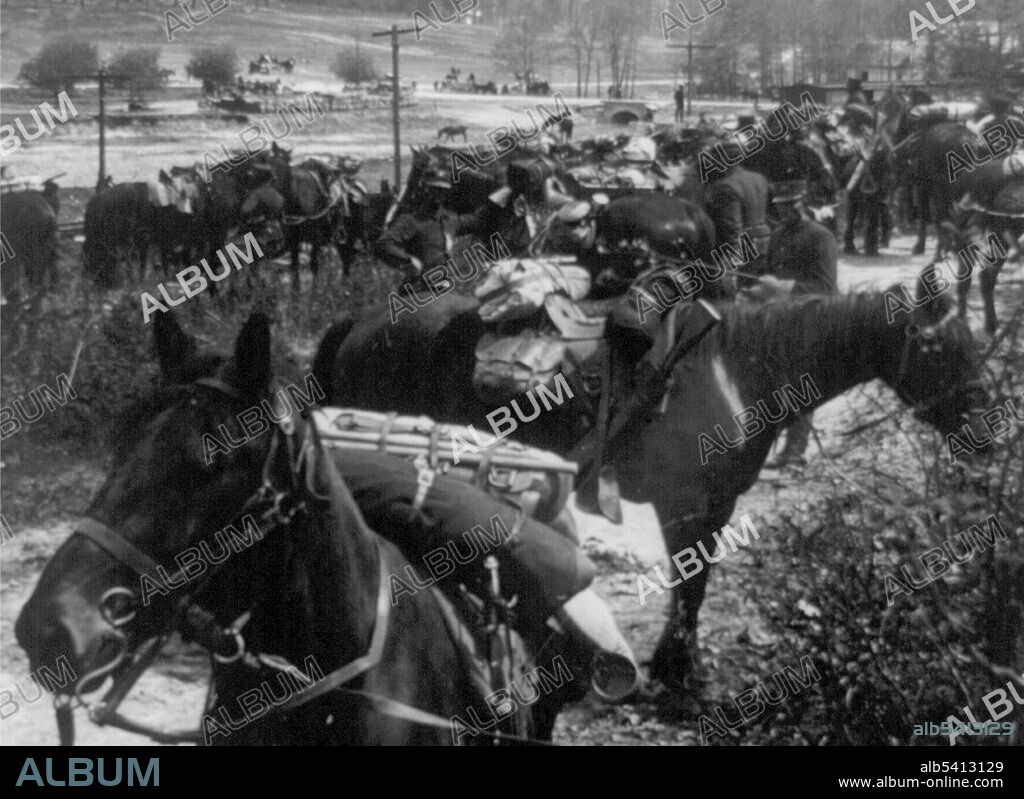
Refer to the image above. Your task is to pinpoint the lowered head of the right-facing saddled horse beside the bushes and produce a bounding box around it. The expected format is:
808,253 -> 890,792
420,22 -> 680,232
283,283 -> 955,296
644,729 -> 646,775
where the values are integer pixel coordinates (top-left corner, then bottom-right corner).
886,263 -> 988,435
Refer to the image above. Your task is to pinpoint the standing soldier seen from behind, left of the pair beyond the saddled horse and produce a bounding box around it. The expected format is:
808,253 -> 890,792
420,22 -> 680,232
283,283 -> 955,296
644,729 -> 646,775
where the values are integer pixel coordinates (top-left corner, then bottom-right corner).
705,138 -> 771,296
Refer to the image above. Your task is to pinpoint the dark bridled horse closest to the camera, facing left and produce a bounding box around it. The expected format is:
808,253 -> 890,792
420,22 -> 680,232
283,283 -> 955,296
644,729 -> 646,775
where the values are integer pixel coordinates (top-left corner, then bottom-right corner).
15,313 -> 577,746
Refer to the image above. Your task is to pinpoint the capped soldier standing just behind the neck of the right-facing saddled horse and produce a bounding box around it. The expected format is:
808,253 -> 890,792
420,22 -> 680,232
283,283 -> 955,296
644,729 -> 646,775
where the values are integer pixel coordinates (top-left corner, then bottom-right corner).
768,180 -> 839,467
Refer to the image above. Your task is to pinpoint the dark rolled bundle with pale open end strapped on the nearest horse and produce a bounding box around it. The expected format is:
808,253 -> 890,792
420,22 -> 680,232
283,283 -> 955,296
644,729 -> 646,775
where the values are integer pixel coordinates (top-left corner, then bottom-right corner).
331,448 -> 640,701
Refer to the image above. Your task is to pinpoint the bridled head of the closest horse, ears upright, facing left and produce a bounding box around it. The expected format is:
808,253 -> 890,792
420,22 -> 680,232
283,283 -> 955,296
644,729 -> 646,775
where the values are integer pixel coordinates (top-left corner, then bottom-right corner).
15,314 -> 308,696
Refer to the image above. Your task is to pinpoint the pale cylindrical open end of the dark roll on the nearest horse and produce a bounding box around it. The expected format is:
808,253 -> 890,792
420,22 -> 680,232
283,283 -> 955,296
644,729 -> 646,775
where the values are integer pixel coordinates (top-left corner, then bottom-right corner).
559,588 -> 642,703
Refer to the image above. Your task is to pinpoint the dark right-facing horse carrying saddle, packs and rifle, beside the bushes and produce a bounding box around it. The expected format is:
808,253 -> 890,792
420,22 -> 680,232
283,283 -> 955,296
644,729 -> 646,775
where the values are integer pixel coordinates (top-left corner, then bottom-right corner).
314,266 -> 987,691
